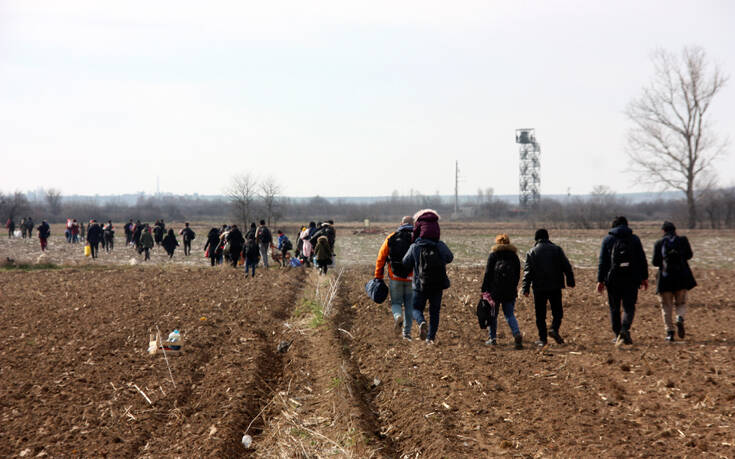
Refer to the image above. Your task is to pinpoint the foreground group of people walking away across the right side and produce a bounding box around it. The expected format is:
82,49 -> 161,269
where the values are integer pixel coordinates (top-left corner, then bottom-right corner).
374,214 -> 697,349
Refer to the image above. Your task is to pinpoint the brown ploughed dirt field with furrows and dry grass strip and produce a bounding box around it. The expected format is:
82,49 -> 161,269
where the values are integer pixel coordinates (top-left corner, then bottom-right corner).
0,226 -> 735,458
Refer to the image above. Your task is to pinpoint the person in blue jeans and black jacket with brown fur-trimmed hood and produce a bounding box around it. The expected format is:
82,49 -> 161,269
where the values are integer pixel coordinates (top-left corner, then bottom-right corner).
482,234 -> 523,349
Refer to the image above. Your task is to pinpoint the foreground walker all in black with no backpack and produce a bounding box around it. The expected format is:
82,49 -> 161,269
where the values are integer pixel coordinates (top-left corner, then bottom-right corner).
523,228 -> 574,346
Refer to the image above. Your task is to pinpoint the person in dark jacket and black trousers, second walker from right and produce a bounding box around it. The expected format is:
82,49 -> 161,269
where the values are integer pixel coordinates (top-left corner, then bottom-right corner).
597,217 -> 648,346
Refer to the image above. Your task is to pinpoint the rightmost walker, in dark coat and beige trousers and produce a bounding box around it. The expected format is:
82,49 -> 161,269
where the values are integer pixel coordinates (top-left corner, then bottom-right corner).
651,222 -> 697,342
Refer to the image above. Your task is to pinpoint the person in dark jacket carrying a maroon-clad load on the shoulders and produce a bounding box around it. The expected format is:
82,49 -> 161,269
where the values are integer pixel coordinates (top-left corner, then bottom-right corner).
401,209 -> 454,344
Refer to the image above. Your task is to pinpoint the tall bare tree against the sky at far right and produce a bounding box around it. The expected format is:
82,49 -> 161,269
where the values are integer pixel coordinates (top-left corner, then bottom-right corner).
626,47 -> 728,228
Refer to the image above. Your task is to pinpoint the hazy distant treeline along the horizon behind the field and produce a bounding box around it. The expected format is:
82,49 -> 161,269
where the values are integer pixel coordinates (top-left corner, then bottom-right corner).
0,188 -> 735,228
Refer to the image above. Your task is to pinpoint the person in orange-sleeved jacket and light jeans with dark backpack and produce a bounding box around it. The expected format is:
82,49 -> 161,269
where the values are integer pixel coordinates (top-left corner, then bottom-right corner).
375,216 -> 413,341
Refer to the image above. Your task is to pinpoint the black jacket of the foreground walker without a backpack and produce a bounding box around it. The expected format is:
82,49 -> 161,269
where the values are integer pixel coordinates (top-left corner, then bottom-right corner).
523,239 -> 574,293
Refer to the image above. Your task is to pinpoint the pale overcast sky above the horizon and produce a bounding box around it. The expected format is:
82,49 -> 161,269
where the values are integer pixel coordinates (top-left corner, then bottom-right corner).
0,0 -> 735,196
